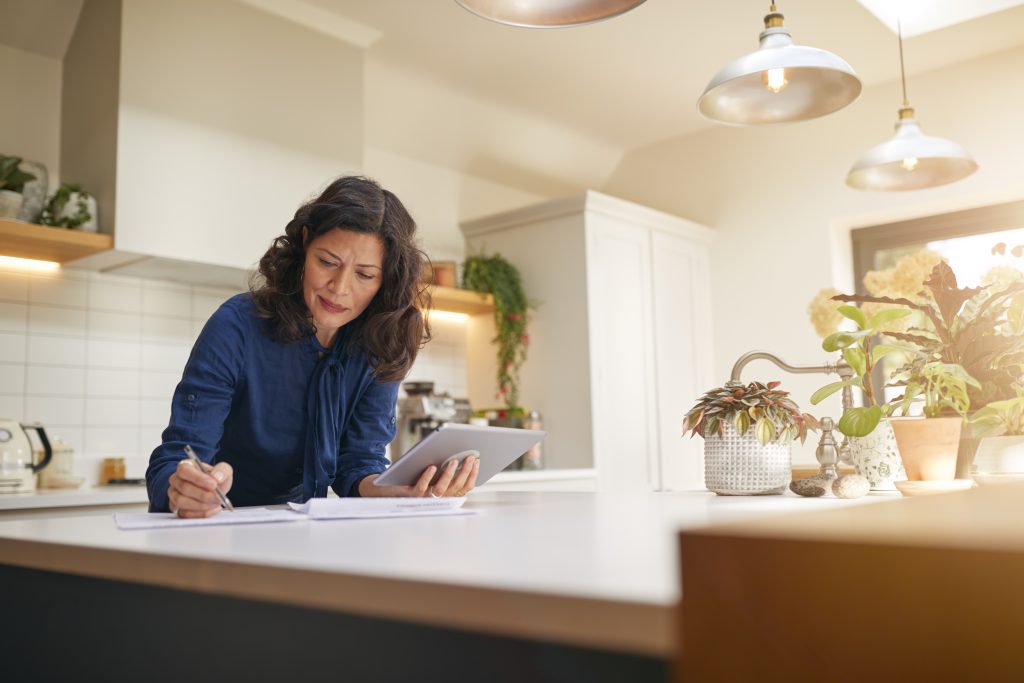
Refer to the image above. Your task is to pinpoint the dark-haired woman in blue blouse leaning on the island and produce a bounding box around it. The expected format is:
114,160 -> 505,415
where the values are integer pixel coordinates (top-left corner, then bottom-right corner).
145,177 -> 479,517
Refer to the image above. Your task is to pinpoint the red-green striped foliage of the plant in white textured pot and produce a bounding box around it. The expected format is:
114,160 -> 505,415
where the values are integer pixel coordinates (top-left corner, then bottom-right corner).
683,381 -> 818,445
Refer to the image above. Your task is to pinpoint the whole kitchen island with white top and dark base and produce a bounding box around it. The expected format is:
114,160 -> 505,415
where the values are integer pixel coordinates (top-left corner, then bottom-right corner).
0,490 -> 888,681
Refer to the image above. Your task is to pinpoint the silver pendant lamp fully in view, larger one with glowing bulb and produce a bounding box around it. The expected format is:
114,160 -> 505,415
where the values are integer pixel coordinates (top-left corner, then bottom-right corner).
697,2 -> 860,126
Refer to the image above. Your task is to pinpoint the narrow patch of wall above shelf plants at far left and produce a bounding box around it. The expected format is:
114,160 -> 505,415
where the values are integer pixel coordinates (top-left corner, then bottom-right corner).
0,45 -> 61,186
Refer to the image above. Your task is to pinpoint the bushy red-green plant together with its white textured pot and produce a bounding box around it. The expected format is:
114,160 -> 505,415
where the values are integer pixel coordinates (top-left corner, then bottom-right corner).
683,382 -> 818,496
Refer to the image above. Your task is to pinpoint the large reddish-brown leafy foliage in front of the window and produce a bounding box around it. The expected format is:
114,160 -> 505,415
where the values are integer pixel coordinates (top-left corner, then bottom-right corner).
833,261 -> 1024,410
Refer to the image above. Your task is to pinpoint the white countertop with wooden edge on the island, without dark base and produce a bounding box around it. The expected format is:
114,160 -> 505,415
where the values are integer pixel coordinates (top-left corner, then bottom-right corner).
0,490 -> 898,656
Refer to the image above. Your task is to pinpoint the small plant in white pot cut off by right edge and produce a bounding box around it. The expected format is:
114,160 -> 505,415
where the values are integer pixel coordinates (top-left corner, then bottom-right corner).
971,388 -> 1024,483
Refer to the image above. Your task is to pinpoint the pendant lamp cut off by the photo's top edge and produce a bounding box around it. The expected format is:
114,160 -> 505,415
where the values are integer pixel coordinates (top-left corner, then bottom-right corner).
455,0 -> 644,29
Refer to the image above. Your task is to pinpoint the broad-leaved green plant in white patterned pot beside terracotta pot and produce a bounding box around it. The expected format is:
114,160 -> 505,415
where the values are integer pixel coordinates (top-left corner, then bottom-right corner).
811,305 -> 910,490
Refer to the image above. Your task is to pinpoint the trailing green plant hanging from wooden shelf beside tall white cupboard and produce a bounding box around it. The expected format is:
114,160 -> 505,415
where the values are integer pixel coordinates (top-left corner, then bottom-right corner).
463,254 -> 529,409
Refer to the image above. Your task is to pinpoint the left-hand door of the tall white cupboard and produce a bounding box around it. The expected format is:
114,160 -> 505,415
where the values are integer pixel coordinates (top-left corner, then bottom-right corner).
587,214 -> 660,490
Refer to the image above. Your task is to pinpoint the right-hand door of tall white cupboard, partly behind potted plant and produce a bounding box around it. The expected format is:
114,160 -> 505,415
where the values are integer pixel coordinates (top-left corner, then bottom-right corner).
651,231 -> 715,490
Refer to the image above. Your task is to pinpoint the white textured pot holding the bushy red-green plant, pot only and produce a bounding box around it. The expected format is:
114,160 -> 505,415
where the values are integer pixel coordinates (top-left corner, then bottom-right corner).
705,422 -> 793,496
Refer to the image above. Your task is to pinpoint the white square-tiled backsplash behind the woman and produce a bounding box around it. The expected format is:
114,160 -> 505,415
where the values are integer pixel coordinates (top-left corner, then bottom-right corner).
0,269 -> 466,483
